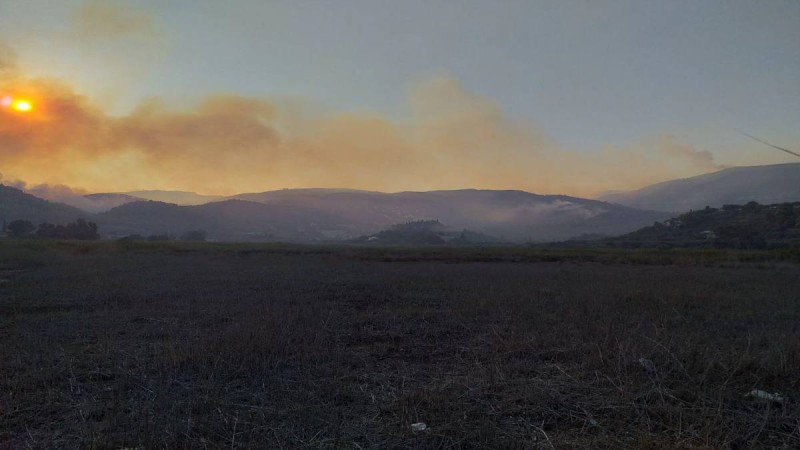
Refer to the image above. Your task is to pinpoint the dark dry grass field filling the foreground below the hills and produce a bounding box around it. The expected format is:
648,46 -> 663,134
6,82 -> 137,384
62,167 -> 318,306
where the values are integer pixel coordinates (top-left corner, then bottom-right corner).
0,241 -> 800,448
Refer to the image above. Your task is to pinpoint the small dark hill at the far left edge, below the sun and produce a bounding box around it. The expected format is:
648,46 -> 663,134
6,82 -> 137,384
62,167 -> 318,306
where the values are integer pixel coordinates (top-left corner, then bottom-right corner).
0,184 -> 91,225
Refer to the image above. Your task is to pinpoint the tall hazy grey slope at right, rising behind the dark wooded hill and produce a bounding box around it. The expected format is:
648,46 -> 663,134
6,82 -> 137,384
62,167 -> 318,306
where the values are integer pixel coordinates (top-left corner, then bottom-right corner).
601,163 -> 800,211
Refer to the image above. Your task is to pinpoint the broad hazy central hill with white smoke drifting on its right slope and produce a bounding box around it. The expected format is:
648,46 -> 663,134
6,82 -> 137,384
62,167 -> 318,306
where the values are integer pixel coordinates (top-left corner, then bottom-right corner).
235,189 -> 669,242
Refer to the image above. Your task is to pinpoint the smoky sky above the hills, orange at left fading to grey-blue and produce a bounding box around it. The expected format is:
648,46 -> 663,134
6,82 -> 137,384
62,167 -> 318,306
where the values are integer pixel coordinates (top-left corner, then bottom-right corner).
0,0 -> 800,196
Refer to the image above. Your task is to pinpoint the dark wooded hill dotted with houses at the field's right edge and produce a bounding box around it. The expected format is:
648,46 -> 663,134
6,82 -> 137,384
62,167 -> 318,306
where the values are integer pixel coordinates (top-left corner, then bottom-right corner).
605,202 -> 800,248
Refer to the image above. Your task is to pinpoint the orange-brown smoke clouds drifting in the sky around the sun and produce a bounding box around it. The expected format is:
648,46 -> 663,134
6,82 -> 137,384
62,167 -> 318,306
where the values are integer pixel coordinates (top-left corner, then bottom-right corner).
0,0 -> 720,198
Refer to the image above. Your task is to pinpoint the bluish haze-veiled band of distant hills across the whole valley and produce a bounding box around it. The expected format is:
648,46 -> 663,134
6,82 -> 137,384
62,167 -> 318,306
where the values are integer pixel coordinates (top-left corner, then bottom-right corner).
0,163 -> 800,243
